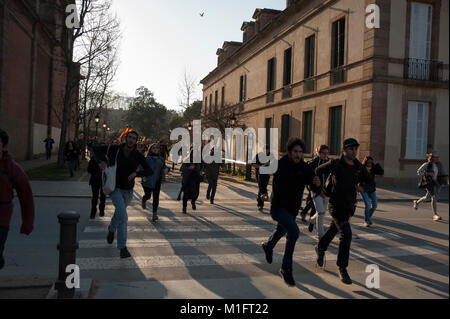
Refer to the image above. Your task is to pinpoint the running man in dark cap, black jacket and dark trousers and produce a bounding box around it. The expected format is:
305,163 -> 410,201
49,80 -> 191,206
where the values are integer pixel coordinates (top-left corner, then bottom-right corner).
315,138 -> 368,285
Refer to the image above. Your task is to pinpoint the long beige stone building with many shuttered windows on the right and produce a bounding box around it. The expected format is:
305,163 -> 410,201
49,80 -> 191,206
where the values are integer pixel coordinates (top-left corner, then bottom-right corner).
201,0 -> 449,186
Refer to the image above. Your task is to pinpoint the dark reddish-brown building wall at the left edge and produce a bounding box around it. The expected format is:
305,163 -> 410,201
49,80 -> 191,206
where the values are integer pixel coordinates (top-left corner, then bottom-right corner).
0,0 -> 80,159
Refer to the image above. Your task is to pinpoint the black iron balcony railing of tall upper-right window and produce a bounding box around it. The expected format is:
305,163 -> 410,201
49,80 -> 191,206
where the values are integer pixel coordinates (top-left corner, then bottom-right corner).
405,58 -> 444,81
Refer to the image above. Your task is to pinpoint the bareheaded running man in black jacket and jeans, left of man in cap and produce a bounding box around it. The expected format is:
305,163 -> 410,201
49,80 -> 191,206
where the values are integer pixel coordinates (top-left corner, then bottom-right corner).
262,139 -> 320,287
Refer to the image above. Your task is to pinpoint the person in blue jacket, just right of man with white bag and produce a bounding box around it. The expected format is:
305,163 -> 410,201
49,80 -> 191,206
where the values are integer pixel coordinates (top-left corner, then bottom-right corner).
141,143 -> 169,222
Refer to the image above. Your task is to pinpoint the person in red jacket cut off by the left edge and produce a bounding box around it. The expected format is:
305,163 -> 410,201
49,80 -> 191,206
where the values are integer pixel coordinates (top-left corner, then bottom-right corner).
0,129 -> 34,269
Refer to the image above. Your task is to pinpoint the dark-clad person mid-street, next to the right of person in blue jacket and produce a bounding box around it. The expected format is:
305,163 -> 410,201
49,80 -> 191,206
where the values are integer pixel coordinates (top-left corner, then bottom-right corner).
180,150 -> 203,214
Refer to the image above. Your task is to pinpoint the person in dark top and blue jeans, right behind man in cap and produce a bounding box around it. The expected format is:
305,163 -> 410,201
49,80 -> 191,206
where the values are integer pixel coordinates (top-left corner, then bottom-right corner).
361,156 -> 384,227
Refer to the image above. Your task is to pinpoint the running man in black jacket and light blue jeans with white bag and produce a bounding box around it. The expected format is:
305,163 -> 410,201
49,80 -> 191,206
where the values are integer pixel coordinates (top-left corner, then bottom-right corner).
93,131 -> 153,258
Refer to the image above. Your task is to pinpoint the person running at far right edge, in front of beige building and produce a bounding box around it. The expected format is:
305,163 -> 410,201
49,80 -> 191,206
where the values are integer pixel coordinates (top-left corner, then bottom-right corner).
413,151 -> 448,221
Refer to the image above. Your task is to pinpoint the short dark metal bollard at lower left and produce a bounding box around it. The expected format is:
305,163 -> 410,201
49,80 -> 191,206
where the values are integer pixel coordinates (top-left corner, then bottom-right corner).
55,211 -> 80,299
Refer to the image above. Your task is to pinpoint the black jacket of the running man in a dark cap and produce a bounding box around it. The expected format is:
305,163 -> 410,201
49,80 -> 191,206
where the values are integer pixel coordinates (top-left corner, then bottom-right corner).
316,156 -> 369,214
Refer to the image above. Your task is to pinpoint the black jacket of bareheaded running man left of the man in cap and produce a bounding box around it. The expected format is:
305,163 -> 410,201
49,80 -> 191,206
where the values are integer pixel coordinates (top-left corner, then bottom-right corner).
272,155 -> 320,216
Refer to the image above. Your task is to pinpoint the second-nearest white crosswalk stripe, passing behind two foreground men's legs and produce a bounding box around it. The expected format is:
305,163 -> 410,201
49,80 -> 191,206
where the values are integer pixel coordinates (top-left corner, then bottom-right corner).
79,233 -> 400,249
